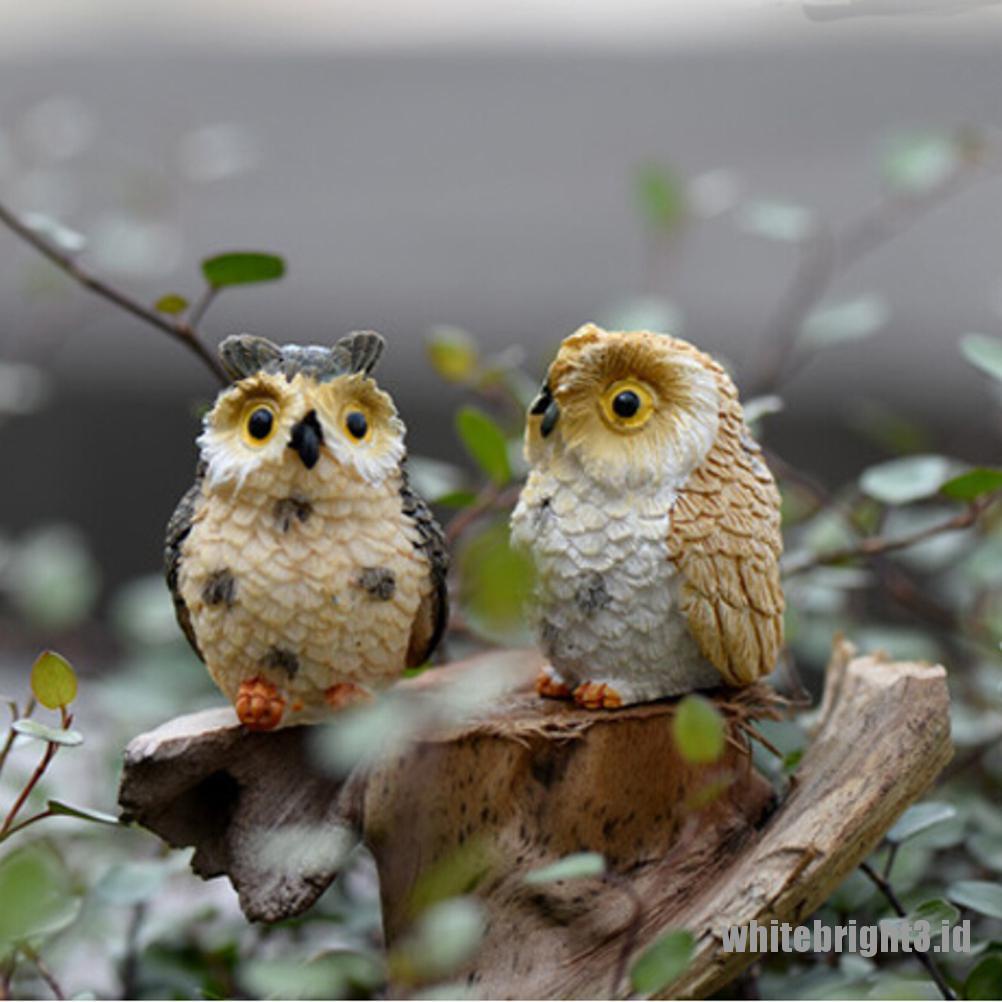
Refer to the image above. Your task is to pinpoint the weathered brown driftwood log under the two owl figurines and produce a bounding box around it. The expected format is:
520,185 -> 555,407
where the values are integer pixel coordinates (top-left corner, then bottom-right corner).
119,642 -> 951,998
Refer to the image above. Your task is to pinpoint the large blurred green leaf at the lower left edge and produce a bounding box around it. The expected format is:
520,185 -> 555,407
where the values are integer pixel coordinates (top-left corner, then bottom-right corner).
0,846 -> 81,952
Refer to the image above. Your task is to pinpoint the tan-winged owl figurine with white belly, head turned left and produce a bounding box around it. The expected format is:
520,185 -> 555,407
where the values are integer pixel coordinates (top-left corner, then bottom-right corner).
512,324 -> 784,708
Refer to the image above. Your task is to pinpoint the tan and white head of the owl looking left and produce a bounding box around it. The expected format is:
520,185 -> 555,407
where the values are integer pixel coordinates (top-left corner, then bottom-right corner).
525,324 -> 727,487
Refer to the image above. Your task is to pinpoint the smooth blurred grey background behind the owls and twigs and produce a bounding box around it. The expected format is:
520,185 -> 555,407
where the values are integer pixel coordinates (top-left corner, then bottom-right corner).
0,0 -> 1002,583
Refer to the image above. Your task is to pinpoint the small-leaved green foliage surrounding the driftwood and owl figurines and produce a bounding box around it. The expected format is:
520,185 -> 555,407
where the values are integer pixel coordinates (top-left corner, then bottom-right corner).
0,125 -> 1002,999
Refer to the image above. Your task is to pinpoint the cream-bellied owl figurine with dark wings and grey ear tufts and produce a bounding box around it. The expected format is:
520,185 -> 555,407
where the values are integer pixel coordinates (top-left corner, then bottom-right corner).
165,332 -> 447,730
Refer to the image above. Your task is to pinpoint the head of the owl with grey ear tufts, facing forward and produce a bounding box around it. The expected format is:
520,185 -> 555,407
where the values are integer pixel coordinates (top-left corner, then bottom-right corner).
198,332 -> 405,489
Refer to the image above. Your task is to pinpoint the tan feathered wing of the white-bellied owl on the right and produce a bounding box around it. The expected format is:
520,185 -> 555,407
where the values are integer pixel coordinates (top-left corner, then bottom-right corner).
668,377 -> 784,685
